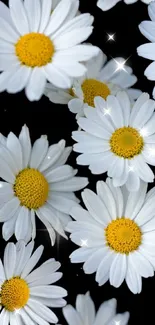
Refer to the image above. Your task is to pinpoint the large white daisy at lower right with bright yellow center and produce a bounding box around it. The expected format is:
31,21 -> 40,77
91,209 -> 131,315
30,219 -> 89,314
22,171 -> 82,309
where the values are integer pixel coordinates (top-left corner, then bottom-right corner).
67,178 -> 155,294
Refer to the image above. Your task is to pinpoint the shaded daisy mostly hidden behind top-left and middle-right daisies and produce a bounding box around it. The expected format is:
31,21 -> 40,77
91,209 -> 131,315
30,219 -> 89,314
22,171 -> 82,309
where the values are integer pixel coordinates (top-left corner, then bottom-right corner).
45,50 -> 141,118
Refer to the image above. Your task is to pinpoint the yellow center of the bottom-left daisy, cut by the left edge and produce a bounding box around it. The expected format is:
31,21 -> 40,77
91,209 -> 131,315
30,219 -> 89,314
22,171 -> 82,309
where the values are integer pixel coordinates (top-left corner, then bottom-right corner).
0,277 -> 30,312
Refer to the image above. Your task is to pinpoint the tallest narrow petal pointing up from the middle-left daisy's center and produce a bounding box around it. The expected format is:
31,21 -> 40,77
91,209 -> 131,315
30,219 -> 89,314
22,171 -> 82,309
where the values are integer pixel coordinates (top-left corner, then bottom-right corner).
19,125 -> 31,168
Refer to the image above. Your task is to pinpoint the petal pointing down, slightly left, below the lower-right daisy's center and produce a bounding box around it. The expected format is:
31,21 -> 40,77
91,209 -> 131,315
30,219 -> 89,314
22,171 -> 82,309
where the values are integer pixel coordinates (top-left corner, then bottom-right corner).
110,254 -> 127,288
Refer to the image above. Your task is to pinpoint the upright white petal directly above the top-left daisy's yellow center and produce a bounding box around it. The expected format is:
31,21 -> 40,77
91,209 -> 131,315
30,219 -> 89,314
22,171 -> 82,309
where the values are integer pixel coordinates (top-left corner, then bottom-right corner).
24,0 -> 41,32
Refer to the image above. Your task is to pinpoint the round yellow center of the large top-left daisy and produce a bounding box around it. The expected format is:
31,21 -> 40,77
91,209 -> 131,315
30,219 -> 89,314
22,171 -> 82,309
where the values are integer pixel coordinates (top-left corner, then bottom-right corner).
15,33 -> 55,68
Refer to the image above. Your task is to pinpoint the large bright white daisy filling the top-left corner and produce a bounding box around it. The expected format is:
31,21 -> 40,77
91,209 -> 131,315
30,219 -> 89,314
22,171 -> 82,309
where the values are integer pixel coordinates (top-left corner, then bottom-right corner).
0,0 -> 98,101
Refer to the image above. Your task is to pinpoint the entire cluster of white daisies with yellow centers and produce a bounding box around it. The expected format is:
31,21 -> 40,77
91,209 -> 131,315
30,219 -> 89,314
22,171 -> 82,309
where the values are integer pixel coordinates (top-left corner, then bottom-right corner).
0,0 -> 155,325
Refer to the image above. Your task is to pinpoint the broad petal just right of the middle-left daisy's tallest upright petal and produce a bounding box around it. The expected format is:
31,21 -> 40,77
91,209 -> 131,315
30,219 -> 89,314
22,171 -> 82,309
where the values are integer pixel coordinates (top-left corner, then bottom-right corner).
30,135 -> 48,169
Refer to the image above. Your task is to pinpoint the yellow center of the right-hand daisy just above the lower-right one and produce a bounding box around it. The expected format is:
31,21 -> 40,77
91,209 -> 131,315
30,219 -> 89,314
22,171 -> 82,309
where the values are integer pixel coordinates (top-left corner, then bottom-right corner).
110,127 -> 144,159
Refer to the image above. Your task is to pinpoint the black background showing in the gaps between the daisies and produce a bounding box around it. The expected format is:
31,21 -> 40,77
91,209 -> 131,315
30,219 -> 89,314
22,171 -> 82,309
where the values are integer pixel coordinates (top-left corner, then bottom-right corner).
0,0 -> 155,325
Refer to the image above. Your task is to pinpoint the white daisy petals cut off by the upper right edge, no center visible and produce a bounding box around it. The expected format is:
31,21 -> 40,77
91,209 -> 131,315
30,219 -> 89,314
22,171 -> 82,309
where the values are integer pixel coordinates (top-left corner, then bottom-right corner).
137,2 -> 155,98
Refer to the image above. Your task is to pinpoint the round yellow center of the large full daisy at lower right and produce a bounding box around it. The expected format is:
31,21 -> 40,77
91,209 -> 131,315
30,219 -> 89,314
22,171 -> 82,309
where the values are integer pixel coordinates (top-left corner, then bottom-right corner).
105,217 -> 142,254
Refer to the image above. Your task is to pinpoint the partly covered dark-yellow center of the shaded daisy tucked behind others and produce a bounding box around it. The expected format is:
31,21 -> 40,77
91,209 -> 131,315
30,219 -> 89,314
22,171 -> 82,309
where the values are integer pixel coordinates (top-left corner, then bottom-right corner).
81,79 -> 110,107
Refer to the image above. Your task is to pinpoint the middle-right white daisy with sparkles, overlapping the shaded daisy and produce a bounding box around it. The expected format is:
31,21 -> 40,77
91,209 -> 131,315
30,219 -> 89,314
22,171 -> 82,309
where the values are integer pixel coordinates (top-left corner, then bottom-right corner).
72,91 -> 155,191
